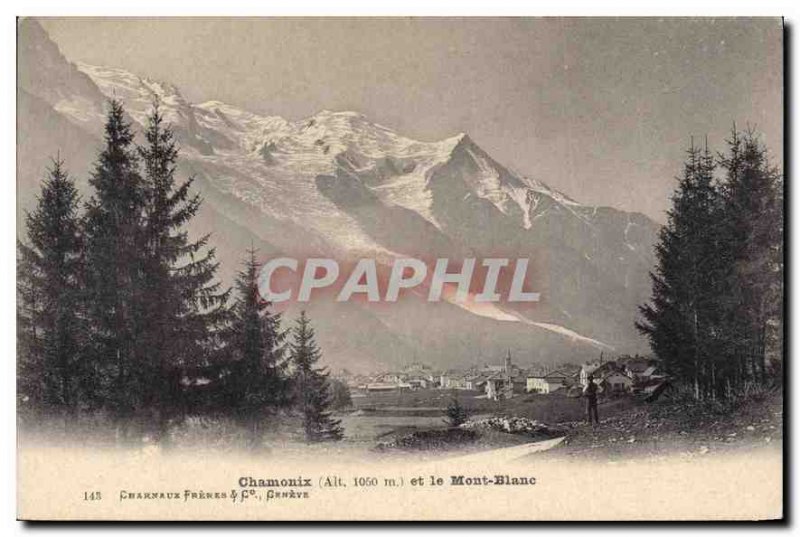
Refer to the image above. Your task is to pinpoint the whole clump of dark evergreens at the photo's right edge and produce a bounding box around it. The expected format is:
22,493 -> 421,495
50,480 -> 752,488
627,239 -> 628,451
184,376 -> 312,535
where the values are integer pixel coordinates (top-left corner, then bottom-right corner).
637,127 -> 783,398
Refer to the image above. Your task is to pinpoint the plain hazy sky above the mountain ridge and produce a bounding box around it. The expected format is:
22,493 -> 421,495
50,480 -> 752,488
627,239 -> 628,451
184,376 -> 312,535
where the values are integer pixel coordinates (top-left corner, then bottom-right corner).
40,18 -> 783,222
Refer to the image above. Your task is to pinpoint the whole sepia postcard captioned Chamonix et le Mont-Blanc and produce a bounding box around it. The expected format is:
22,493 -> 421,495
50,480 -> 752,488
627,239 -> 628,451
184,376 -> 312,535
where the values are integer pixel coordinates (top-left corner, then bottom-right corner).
16,17 -> 785,521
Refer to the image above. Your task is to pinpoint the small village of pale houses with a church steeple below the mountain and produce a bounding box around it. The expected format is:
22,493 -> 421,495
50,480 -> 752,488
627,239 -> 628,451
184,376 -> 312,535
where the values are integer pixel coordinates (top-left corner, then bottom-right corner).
336,351 -> 667,401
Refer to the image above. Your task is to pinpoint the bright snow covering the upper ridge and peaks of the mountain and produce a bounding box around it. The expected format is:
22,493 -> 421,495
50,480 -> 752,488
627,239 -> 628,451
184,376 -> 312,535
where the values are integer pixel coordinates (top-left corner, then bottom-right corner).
73,63 -> 612,260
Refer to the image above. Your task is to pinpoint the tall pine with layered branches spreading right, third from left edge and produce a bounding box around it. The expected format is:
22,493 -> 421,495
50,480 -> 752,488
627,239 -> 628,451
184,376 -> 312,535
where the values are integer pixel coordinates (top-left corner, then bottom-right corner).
137,99 -> 229,439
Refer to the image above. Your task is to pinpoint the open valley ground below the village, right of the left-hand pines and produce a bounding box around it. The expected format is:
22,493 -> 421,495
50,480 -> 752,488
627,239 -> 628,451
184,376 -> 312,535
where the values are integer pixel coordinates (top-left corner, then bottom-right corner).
344,390 -> 783,461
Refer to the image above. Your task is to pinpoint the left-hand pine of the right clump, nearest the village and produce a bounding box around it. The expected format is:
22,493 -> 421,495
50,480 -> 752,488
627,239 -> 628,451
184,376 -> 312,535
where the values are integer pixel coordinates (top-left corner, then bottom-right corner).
636,138 -> 724,398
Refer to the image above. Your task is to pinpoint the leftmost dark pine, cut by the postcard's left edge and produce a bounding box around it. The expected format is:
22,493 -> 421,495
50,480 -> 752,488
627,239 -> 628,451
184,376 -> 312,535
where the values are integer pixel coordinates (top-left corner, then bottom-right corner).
17,159 -> 85,414
